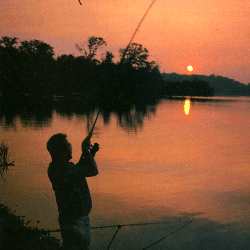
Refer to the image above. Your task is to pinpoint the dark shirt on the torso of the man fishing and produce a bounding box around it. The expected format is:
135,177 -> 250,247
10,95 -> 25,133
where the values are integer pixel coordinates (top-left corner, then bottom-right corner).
48,162 -> 92,224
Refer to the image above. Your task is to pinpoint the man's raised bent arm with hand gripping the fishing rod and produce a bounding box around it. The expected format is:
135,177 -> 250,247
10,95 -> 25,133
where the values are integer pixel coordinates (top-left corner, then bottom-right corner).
76,135 -> 98,177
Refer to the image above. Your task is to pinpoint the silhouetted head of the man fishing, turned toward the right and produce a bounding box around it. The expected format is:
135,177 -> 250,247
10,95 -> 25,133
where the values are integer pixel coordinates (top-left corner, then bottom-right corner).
47,133 -> 72,162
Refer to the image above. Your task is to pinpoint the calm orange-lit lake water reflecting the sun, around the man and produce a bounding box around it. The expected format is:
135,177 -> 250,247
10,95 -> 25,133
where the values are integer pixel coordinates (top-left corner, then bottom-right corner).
0,97 -> 250,249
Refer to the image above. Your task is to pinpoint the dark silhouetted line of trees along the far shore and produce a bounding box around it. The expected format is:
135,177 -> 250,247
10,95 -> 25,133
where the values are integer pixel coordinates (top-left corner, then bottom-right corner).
0,36 -> 215,101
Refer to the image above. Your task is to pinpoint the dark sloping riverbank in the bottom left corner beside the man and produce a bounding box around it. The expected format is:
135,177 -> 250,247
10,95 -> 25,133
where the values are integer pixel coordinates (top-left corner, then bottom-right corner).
0,203 -> 61,250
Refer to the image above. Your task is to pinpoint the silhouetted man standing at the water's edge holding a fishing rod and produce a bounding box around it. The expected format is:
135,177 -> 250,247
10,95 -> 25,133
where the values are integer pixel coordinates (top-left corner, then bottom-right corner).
47,133 -> 99,250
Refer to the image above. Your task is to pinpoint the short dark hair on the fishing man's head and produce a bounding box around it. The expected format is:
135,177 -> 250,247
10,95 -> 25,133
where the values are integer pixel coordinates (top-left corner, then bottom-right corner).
47,133 -> 69,159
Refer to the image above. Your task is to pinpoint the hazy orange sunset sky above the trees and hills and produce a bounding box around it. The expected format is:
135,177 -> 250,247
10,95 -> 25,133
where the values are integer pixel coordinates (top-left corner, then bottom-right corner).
0,0 -> 250,84
